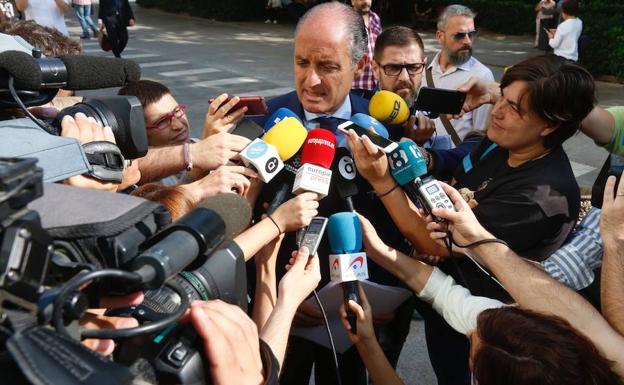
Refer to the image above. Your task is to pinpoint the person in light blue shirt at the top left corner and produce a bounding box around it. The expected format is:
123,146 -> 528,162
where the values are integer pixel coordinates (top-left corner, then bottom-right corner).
15,0 -> 71,36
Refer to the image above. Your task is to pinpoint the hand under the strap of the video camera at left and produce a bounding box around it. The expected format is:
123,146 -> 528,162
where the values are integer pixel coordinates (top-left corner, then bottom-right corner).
61,112 -> 118,192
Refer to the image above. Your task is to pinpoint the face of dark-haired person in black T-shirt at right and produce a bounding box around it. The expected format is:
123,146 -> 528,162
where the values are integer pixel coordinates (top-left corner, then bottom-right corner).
487,81 -> 556,151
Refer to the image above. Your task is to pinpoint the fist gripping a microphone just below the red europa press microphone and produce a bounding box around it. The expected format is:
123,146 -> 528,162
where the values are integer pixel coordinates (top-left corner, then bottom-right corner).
271,192 -> 319,233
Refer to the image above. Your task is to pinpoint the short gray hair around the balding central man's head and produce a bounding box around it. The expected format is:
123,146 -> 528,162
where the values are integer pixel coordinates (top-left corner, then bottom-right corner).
295,1 -> 368,66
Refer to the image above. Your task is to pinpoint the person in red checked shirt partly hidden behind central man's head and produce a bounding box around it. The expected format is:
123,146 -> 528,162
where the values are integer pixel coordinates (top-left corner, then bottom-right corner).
351,0 -> 381,90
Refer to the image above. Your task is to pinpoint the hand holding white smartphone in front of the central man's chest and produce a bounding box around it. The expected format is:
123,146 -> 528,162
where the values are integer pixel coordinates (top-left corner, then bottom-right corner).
345,130 -> 390,185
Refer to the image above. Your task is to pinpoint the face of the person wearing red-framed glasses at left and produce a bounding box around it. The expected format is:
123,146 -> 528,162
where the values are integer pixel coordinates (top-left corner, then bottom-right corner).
143,94 -> 189,147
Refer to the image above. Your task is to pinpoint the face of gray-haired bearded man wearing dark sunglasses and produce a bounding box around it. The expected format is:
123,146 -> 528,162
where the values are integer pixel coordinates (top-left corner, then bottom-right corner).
436,16 -> 475,65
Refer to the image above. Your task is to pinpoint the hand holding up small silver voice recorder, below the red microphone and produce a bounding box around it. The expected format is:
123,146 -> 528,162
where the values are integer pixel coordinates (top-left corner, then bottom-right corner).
277,246 -> 321,309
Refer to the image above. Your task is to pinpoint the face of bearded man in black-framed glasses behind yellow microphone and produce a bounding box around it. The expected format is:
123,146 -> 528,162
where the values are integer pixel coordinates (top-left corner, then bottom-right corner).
373,44 -> 426,107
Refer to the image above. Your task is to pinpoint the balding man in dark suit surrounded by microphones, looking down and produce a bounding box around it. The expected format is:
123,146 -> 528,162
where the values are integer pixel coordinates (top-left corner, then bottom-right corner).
251,2 -> 413,385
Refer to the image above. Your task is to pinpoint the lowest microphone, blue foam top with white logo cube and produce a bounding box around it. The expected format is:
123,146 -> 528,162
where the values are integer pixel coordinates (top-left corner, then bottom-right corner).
327,212 -> 368,333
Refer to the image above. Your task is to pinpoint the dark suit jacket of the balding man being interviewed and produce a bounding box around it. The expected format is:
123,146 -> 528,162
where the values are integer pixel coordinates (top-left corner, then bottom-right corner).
252,91 -> 409,287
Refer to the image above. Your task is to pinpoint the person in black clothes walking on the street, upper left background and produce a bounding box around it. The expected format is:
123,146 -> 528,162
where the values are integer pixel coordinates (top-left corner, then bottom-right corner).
98,0 -> 135,57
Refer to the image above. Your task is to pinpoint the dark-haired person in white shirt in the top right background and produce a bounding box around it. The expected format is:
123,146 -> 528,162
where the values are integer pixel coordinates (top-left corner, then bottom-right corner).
548,0 -> 583,61
